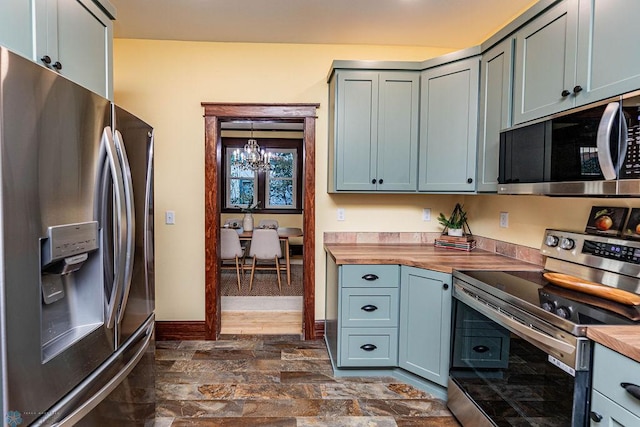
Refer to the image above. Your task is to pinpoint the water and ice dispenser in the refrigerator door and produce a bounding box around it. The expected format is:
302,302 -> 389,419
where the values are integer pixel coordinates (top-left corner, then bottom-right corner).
40,221 -> 104,362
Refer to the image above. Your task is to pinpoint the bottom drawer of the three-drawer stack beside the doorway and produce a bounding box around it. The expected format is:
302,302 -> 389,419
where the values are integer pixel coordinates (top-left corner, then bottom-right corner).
340,328 -> 398,367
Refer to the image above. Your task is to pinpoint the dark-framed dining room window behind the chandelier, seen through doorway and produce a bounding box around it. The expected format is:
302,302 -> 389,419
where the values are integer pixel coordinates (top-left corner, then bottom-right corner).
222,138 -> 302,213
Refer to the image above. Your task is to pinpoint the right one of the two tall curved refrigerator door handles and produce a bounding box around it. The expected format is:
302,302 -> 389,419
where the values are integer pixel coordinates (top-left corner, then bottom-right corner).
114,130 -> 136,323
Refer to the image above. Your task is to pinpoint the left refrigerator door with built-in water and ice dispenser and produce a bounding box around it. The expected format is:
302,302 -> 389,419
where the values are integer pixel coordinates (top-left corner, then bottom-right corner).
0,48 -> 115,425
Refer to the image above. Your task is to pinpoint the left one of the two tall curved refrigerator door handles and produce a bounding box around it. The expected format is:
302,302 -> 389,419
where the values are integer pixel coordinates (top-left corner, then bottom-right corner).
102,127 -> 127,329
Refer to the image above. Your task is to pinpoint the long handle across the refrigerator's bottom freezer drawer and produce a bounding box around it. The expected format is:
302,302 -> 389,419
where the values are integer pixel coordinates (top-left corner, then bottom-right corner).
41,316 -> 155,427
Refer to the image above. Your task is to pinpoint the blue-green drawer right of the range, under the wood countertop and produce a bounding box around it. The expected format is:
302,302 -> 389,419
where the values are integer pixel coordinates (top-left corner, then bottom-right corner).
593,344 -> 640,416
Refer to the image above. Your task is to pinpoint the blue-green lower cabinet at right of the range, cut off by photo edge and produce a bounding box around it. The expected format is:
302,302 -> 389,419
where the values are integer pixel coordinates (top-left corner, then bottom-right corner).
589,343 -> 640,427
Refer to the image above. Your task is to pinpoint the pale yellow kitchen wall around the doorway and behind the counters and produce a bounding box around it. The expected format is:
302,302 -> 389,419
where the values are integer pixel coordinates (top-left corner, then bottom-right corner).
114,39 -> 640,320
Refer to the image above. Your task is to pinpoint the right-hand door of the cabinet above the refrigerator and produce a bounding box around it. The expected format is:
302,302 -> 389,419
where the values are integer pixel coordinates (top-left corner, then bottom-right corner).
35,0 -> 113,99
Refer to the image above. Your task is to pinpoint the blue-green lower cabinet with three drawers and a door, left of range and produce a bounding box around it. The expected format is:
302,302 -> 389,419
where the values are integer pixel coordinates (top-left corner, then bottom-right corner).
324,254 -> 451,399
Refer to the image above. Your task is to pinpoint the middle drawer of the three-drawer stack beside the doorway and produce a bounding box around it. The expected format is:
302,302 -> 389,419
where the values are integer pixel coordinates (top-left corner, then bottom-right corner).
340,288 -> 399,327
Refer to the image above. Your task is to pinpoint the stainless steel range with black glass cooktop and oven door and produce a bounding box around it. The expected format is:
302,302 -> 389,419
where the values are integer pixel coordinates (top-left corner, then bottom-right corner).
448,230 -> 640,427
